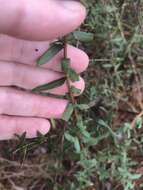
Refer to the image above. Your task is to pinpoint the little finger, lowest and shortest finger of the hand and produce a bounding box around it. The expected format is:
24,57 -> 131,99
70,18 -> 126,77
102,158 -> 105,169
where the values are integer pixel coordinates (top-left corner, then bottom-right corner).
0,115 -> 50,140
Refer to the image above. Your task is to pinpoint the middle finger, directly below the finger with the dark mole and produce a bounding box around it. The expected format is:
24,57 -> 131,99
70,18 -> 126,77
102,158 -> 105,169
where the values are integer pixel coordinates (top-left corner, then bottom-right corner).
0,61 -> 85,95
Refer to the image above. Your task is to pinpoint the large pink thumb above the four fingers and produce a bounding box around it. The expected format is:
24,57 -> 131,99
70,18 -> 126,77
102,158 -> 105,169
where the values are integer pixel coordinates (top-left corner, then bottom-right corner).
0,0 -> 86,40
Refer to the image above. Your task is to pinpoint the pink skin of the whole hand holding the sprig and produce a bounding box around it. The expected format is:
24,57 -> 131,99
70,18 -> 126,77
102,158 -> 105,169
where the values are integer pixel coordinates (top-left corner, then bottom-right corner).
0,0 -> 89,140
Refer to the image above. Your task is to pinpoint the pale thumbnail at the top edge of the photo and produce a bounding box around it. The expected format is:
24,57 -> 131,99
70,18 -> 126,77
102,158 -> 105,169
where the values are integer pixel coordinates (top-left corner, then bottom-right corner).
62,0 -> 83,11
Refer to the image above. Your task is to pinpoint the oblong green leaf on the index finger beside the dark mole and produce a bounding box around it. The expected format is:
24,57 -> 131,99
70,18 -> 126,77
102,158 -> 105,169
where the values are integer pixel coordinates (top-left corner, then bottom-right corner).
37,43 -> 63,65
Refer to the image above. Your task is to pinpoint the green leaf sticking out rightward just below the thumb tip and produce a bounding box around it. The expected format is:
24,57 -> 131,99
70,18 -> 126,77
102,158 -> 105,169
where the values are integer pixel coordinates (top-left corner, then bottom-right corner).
73,31 -> 94,42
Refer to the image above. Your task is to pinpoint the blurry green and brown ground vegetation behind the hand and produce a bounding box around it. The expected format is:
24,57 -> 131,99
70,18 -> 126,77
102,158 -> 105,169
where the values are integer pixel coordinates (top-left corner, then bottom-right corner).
0,0 -> 143,190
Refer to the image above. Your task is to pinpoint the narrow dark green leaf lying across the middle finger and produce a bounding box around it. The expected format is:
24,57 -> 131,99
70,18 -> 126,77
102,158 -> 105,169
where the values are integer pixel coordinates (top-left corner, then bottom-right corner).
32,77 -> 66,92
